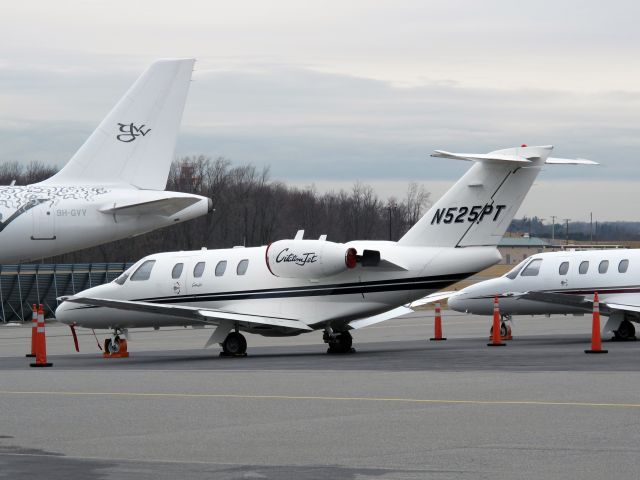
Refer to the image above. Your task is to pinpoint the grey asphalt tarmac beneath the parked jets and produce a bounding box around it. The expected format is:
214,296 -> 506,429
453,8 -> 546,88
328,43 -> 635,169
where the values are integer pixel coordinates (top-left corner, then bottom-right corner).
0,312 -> 640,480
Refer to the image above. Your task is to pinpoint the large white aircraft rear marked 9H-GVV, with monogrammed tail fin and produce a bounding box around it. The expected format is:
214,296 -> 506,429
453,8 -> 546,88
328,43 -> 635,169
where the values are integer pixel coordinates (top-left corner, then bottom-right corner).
0,59 -> 212,263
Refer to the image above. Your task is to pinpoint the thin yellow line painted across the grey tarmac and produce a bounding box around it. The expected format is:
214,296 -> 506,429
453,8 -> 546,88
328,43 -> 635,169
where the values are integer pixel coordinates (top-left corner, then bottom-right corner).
0,390 -> 640,409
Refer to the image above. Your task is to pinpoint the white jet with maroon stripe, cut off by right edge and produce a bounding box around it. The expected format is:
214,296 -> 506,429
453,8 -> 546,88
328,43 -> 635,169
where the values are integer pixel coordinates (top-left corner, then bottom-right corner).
448,249 -> 640,339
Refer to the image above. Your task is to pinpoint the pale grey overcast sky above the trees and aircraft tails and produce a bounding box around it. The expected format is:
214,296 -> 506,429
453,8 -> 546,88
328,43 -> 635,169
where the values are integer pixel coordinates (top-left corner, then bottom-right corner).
0,0 -> 640,220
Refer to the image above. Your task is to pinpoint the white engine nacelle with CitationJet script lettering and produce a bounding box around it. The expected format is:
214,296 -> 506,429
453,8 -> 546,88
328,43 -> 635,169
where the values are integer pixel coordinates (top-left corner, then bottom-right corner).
265,240 -> 357,279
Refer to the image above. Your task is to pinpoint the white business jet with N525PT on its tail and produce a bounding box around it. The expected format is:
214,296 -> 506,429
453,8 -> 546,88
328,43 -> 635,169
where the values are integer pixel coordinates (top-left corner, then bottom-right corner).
56,146 -> 596,354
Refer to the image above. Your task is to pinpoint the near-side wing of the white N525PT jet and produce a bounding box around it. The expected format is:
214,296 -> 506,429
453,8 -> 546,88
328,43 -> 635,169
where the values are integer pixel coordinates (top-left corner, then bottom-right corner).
65,297 -> 313,331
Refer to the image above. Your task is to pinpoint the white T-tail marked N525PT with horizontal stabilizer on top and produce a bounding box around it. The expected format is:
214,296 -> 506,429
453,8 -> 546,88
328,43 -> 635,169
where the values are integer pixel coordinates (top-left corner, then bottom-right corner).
398,146 -> 596,247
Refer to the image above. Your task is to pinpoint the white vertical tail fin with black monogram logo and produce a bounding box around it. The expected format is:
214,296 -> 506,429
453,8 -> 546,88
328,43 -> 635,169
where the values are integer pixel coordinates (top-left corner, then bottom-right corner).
42,59 -> 195,190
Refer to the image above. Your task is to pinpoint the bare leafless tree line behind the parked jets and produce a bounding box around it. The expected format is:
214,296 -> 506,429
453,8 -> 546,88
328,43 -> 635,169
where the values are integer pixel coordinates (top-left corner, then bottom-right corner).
0,155 -> 429,263
